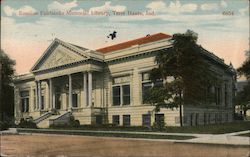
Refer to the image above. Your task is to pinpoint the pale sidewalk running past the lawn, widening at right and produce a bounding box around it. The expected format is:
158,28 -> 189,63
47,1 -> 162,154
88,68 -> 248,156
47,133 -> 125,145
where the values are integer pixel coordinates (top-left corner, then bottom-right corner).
1,128 -> 250,146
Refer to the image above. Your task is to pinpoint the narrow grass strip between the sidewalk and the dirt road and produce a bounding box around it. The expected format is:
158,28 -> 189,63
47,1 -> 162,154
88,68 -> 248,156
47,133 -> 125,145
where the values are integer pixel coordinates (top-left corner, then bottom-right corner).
18,128 -> 195,140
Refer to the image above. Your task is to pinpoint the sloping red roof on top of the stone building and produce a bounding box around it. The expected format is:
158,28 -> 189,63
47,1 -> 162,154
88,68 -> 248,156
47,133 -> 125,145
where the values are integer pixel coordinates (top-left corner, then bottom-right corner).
96,33 -> 172,53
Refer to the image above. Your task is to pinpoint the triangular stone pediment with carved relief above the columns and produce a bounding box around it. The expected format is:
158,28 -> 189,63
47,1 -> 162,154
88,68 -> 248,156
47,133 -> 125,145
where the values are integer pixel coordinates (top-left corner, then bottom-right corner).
31,39 -> 89,71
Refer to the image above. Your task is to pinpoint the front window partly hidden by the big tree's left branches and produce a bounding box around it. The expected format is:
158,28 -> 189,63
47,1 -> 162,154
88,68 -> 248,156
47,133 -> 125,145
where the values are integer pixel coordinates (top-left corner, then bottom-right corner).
142,73 -> 163,103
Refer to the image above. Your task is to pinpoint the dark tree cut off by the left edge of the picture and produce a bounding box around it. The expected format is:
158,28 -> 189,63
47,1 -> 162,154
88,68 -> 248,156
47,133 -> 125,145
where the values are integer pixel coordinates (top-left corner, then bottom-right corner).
0,50 -> 15,121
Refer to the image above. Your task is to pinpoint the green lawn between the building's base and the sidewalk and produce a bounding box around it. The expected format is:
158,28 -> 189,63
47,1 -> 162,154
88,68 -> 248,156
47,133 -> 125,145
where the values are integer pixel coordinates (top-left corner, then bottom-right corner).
48,121 -> 250,134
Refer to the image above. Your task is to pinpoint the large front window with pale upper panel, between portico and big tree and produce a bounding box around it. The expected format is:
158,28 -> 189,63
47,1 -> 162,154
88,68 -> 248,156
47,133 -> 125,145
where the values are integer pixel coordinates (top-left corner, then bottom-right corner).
112,76 -> 130,106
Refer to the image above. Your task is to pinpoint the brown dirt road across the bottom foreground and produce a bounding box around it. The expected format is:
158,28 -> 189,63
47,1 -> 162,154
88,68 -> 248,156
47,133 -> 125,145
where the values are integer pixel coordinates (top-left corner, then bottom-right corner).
1,135 -> 250,157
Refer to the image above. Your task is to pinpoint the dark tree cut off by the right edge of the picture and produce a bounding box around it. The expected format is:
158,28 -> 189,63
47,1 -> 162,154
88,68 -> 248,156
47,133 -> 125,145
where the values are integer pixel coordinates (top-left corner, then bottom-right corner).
236,50 -> 250,115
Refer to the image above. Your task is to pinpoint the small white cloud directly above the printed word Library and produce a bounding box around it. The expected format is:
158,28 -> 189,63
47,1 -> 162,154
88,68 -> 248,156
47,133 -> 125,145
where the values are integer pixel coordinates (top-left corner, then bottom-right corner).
89,1 -> 126,12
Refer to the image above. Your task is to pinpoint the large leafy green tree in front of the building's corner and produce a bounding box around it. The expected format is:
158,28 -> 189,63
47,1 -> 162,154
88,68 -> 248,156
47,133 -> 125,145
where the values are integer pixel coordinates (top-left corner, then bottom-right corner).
144,30 -> 217,126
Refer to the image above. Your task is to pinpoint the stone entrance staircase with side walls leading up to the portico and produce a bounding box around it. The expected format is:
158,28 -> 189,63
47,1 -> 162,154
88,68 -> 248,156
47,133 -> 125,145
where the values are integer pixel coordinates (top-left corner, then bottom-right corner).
34,111 -> 71,128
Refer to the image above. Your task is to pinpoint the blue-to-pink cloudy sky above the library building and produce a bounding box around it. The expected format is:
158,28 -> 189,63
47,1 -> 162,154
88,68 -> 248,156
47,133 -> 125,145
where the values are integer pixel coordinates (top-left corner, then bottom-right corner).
1,0 -> 250,78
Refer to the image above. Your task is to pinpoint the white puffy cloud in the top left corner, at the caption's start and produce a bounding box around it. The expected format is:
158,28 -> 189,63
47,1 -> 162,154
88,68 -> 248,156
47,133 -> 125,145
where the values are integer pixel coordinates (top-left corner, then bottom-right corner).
3,5 -> 36,16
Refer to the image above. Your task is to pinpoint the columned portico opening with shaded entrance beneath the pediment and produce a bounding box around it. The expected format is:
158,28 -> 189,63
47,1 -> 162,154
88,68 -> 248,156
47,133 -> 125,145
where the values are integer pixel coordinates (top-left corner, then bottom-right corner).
35,71 -> 93,111
